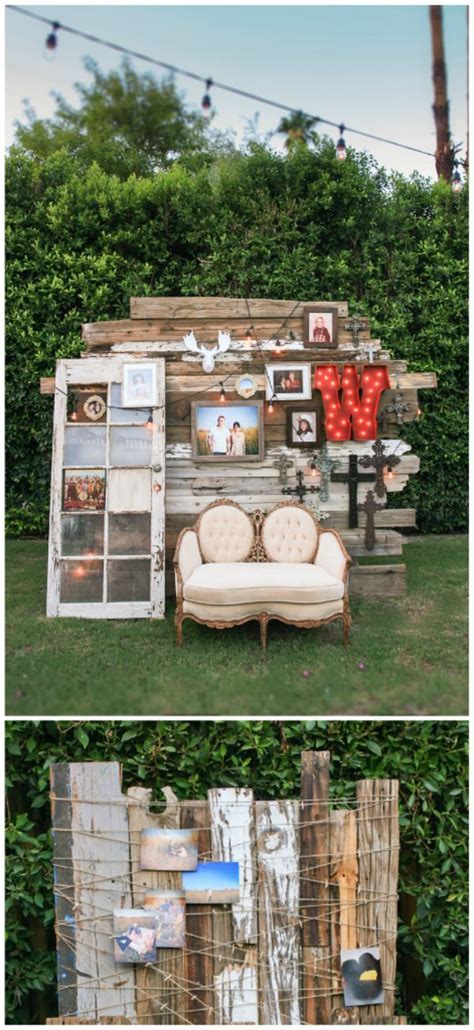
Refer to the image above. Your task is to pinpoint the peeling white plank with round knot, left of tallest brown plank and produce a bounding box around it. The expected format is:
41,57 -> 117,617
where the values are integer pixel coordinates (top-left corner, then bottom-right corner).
256,801 -> 301,1025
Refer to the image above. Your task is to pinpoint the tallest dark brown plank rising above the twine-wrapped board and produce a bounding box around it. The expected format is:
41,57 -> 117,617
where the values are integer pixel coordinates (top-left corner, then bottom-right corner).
300,751 -> 332,1025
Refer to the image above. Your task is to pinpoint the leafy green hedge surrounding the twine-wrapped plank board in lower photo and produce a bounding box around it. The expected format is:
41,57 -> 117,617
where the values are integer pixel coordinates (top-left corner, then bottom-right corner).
6,721 -> 468,1025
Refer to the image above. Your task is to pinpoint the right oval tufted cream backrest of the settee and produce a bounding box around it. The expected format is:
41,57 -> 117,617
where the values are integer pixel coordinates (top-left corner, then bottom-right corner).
262,505 -> 317,561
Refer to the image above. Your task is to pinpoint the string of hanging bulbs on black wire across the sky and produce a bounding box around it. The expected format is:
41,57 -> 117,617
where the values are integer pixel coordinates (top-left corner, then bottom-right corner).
8,4 -> 463,193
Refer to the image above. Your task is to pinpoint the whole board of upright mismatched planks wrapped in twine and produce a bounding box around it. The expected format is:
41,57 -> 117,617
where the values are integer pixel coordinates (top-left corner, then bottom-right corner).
48,752 -> 404,1025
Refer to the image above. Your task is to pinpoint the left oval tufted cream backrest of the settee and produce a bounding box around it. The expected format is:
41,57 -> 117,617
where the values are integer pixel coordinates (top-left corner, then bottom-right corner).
198,504 -> 253,561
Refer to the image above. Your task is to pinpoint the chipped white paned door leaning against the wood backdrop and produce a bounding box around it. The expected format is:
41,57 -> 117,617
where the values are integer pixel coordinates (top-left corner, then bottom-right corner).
46,355 -> 165,619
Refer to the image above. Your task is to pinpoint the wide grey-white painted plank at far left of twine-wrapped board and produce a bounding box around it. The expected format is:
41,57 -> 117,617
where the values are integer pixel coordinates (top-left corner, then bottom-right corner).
50,762 -> 136,1022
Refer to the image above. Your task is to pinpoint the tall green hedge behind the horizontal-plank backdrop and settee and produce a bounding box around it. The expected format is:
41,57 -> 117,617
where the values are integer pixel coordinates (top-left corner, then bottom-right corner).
6,141 -> 468,535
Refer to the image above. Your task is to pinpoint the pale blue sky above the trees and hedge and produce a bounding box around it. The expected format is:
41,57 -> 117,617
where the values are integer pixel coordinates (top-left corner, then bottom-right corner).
5,3 -> 467,178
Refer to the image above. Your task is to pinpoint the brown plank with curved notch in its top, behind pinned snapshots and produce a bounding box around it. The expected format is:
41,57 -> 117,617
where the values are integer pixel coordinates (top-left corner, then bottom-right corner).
128,787 -> 184,1026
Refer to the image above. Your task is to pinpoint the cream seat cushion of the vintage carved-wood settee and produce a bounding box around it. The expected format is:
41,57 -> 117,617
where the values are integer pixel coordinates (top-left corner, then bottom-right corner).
183,561 -> 344,605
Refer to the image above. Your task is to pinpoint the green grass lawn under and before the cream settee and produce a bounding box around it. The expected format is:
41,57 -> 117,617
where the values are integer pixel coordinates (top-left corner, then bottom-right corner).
6,537 -> 468,717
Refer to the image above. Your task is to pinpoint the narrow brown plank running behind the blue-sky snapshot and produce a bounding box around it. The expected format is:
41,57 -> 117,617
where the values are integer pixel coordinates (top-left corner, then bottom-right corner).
181,801 -> 214,1026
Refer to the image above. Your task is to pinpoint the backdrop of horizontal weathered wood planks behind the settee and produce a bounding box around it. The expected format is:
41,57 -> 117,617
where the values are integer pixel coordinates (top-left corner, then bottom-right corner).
40,297 -> 437,596
